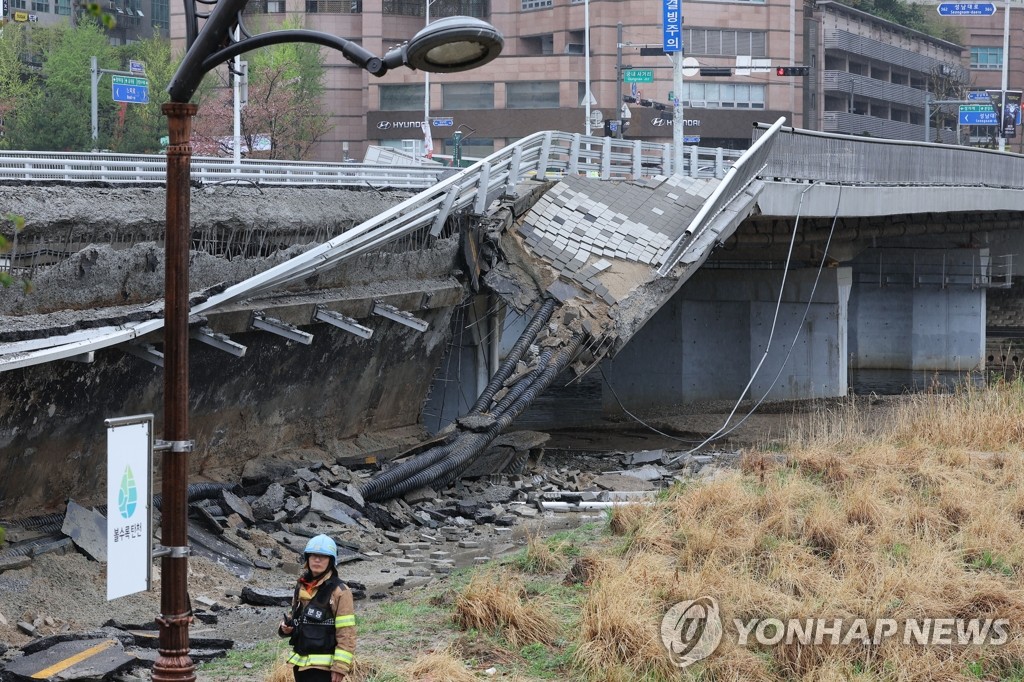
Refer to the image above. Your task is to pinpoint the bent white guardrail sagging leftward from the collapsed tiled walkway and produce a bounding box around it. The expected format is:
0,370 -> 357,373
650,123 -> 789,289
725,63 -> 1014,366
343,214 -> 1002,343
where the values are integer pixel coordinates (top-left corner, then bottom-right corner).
0,131 -> 753,372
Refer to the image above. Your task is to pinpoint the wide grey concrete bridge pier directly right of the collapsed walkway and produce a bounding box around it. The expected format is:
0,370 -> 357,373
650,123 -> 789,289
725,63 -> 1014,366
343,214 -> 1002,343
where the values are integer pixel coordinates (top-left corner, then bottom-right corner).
603,267 -> 852,413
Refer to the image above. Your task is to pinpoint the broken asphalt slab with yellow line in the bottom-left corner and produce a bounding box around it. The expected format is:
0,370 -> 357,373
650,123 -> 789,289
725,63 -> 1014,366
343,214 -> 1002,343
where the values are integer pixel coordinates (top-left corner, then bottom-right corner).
4,638 -> 138,682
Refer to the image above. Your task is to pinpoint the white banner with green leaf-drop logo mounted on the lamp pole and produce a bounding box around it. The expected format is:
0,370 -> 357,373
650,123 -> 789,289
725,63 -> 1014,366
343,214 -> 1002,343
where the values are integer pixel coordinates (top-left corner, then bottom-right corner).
104,415 -> 153,601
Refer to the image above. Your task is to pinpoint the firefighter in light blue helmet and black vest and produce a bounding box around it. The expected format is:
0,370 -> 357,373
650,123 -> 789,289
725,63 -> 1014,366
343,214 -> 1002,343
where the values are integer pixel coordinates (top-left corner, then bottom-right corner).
278,536 -> 355,682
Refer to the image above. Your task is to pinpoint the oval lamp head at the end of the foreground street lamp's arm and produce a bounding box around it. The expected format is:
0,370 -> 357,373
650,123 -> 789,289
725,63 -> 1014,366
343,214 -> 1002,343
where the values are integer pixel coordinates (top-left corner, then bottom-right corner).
384,16 -> 505,74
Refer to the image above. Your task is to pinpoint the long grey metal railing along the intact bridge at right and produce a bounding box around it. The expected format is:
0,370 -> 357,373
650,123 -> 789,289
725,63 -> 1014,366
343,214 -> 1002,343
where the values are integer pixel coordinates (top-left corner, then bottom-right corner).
754,124 -> 1024,189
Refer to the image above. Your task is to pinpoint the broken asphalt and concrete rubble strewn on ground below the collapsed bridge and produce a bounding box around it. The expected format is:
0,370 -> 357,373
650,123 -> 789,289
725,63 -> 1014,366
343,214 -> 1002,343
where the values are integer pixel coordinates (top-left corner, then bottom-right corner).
0,432 -> 735,682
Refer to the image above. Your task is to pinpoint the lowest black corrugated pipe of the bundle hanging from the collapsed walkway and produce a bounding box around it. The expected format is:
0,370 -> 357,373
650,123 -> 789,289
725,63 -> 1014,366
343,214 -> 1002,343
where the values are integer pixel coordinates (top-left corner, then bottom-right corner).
364,333 -> 586,499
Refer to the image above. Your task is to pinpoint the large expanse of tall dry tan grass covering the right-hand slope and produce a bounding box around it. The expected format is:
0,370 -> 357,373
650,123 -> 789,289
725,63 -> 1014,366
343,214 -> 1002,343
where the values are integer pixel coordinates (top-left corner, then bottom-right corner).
589,383 -> 1024,680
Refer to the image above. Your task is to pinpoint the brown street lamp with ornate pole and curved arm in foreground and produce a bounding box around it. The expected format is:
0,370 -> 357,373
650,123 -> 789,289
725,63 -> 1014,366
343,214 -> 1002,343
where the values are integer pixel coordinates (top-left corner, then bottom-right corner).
153,6 -> 505,682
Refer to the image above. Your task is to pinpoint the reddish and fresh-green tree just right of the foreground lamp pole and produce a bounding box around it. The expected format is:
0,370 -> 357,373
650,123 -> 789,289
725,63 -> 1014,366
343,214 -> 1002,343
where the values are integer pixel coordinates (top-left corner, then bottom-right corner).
194,16 -> 331,159
